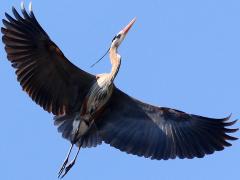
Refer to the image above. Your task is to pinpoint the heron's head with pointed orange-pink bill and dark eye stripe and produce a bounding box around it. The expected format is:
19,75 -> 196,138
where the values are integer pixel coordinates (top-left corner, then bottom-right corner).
111,18 -> 136,48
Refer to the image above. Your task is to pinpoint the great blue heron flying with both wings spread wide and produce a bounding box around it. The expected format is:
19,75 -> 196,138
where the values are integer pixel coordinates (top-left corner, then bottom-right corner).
1,4 -> 237,177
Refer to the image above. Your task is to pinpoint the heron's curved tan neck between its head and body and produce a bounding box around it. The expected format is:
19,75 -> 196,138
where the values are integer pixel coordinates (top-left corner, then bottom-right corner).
109,46 -> 121,81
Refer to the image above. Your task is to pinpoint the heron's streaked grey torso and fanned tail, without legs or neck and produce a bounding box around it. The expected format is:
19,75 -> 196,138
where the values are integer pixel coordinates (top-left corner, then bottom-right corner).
54,74 -> 113,147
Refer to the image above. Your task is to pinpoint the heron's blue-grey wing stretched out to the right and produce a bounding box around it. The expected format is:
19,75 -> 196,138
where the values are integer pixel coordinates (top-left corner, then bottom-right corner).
96,88 -> 237,160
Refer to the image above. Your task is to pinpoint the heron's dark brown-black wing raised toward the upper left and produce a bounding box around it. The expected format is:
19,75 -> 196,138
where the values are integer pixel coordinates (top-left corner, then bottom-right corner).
1,4 -> 95,115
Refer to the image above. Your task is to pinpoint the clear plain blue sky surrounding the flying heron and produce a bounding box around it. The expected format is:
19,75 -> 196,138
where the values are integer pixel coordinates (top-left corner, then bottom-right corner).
0,0 -> 240,180
